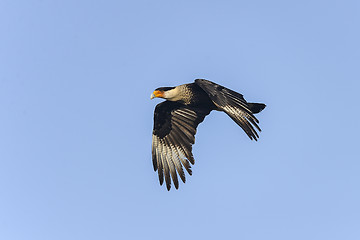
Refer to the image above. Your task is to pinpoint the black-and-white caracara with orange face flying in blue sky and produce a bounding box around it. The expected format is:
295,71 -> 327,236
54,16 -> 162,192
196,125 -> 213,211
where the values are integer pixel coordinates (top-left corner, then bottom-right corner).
150,79 -> 266,190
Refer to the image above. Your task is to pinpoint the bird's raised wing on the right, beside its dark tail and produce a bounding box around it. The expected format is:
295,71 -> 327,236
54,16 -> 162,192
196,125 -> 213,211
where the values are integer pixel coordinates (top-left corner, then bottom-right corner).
195,79 -> 265,140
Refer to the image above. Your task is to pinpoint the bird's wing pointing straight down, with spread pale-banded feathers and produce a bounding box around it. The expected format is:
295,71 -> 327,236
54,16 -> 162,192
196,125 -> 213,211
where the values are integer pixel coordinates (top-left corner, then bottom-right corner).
152,101 -> 211,190
